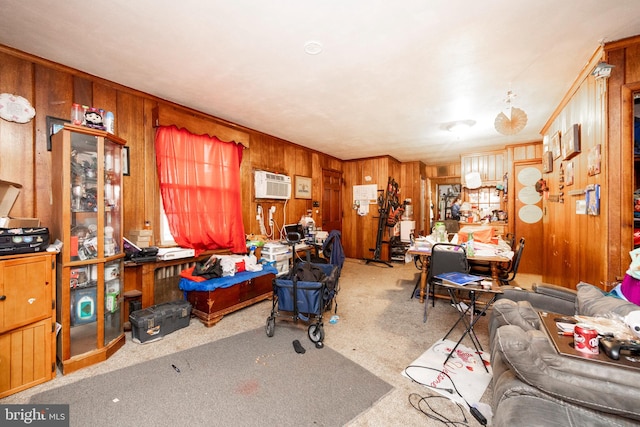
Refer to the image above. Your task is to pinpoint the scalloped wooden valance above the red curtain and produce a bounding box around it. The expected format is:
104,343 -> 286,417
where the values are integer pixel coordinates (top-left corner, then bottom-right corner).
152,104 -> 251,147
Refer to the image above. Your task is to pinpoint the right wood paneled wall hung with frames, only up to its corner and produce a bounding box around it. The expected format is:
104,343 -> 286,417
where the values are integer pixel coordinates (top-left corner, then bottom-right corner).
543,69 -> 611,289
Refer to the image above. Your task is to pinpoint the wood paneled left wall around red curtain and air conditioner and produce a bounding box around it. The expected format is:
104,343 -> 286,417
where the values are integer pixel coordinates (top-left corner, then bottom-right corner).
0,46 -> 343,254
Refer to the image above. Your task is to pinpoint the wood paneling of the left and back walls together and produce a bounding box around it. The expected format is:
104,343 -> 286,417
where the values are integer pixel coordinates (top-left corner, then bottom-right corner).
0,45 -> 548,259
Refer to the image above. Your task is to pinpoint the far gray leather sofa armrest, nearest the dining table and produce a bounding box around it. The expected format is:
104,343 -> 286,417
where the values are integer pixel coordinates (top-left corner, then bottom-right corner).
498,283 -> 577,316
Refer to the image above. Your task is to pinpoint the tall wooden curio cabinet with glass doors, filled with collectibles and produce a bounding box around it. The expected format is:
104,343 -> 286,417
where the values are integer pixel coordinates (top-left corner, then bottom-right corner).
51,125 -> 125,374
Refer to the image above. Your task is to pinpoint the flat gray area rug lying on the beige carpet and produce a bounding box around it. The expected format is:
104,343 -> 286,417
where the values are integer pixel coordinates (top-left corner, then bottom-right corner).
31,322 -> 392,426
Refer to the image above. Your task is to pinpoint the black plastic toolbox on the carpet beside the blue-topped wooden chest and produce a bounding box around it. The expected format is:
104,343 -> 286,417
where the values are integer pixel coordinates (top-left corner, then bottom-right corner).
129,300 -> 191,343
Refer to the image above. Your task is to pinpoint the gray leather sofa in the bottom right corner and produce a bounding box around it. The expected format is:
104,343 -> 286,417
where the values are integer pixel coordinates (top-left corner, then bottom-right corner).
489,283 -> 640,427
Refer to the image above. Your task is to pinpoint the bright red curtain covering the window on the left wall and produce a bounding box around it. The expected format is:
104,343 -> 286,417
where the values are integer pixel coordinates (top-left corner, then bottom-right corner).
155,126 -> 247,253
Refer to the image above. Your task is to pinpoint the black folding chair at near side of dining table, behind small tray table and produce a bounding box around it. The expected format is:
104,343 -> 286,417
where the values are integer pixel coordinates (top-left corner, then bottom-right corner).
424,243 -> 469,322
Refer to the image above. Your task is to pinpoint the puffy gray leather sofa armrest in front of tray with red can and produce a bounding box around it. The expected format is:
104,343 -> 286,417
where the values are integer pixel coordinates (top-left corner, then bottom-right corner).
493,325 -> 640,420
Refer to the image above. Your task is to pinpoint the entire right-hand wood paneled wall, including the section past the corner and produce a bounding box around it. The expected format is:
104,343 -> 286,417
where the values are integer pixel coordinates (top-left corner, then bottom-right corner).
542,37 -> 640,288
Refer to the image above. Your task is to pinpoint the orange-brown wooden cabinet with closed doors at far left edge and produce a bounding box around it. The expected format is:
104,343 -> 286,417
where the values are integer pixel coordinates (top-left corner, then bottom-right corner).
0,253 -> 56,398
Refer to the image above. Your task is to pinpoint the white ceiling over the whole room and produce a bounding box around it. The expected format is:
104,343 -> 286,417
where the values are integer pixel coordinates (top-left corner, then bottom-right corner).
0,0 -> 640,164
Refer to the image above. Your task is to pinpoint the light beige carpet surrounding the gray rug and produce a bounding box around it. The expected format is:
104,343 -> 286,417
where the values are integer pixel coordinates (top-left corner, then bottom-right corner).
0,259 -> 535,427
